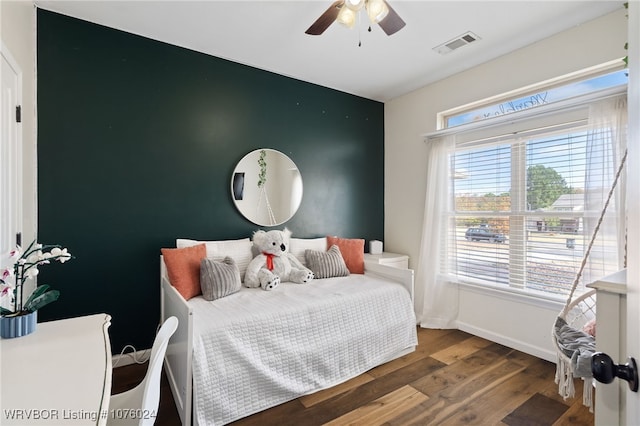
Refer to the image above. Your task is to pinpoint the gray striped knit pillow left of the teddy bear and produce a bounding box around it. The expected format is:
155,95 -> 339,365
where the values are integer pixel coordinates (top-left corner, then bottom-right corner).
200,256 -> 240,300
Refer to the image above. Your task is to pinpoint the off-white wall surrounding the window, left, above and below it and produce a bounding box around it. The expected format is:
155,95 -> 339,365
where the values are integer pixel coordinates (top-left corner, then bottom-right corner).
384,3 -> 627,360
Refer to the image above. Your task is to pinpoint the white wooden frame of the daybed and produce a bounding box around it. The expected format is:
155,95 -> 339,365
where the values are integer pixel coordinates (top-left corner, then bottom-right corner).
160,256 -> 415,426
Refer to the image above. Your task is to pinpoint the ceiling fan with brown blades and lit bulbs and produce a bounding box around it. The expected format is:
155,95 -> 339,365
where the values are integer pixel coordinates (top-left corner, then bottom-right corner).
305,0 -> 406,35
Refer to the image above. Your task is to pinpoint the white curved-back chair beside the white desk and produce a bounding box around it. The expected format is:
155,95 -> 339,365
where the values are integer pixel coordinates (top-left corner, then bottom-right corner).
107,317 -> 178,426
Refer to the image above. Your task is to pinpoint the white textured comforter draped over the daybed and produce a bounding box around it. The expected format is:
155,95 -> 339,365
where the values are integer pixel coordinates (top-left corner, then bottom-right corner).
189,274 -> 417,425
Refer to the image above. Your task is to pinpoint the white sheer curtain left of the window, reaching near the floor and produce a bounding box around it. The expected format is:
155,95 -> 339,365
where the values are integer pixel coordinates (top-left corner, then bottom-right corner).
416,136 -> 458,328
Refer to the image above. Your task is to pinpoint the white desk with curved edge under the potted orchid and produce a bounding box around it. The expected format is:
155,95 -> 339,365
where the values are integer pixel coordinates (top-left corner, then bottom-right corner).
0,314 -> 111,426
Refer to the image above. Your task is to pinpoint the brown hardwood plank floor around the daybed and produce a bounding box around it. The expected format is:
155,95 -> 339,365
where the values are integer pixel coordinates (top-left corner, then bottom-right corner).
113,328 -> 594,426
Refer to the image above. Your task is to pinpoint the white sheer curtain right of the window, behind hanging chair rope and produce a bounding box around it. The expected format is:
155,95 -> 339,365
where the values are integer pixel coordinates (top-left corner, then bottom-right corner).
582,95 -> 627,283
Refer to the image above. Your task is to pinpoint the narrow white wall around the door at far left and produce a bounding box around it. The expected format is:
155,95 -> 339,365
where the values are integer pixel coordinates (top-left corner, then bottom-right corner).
0,0 -> 37,244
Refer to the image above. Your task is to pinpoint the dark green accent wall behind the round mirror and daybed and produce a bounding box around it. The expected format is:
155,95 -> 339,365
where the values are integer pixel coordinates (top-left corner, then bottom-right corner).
37,10 -> 384,353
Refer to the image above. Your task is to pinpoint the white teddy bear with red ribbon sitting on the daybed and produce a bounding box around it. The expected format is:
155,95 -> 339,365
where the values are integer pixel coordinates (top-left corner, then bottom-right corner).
244,228 -> 313,290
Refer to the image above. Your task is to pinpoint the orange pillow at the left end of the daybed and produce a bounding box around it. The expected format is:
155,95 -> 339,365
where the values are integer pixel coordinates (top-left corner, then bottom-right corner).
160,244 -> 207,300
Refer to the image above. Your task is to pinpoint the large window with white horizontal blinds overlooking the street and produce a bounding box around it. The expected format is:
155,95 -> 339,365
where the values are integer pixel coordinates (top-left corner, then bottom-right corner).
442,96 -> 623,296
